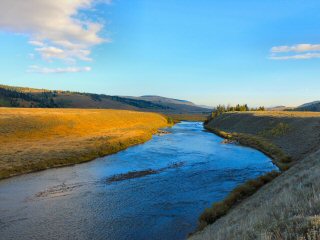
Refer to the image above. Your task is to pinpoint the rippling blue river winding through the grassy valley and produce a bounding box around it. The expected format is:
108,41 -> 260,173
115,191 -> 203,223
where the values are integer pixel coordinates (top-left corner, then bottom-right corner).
0,122 -> 277,240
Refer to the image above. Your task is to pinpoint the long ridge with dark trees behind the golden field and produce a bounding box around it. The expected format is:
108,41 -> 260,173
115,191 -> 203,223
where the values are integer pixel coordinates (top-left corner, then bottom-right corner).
0,85 -> 209,113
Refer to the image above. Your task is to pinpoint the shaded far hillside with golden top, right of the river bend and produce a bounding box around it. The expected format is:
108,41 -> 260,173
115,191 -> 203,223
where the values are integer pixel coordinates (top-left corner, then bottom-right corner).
207,111 -> 320,161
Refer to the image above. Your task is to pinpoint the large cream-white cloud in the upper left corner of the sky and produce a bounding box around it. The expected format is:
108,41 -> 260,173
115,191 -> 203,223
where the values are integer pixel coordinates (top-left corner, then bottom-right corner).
0,0 -> 111,72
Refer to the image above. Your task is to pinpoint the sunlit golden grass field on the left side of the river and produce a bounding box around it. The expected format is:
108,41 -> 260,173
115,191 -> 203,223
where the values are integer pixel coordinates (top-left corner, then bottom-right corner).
0,108 -> 168,179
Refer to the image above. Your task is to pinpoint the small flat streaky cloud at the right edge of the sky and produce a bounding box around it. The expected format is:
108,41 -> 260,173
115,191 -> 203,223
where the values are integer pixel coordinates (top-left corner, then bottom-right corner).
270,44 -> 320,60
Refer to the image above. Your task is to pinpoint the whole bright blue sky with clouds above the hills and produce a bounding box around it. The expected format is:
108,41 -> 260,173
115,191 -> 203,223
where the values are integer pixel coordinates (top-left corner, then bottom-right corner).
0,0 -> 320,106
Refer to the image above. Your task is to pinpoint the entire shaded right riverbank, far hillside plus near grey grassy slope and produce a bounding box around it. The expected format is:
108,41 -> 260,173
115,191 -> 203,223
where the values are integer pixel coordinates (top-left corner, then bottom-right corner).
190,112 -> 320,240
